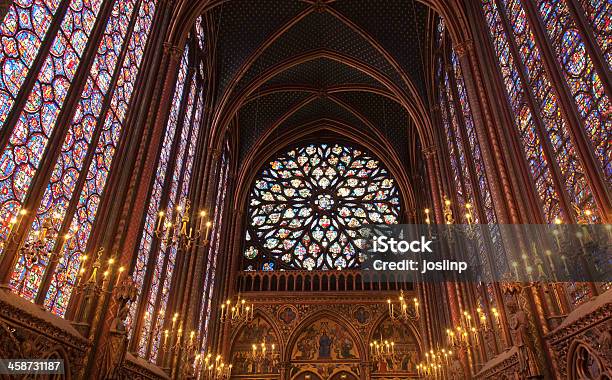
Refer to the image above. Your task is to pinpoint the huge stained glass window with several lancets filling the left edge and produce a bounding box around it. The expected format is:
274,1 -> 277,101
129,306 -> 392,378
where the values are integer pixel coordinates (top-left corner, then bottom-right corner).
0,0 -> 156,316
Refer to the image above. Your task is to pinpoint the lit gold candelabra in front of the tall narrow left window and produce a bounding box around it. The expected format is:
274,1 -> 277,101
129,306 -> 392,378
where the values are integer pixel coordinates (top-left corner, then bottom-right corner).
155,200 -> 212,250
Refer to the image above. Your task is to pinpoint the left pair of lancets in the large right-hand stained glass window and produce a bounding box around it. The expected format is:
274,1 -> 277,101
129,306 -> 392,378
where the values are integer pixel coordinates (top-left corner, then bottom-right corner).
482,0 -> 601,223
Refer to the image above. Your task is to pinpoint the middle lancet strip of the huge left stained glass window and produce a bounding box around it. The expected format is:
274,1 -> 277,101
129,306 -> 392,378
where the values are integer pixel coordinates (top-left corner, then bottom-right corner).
0,0 -> 102,249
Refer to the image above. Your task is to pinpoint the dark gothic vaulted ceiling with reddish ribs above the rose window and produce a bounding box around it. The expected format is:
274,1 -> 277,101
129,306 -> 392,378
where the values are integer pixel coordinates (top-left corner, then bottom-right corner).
208,0 -> 435,164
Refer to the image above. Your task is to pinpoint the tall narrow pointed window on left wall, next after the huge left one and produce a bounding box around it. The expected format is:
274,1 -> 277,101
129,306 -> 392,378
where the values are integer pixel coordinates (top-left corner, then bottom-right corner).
127,19 -> 205,362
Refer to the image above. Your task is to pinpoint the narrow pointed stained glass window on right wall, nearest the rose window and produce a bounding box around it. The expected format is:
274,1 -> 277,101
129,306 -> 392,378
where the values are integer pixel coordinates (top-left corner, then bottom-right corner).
436,19 -> 507,280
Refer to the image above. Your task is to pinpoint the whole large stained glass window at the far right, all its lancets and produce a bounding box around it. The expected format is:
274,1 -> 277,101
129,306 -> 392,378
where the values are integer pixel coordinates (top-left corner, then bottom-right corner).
482,0 -> 612,223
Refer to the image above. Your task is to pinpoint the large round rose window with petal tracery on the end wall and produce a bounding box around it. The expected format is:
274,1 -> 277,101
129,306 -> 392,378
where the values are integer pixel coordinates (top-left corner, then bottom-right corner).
244,144 -> 400,270
